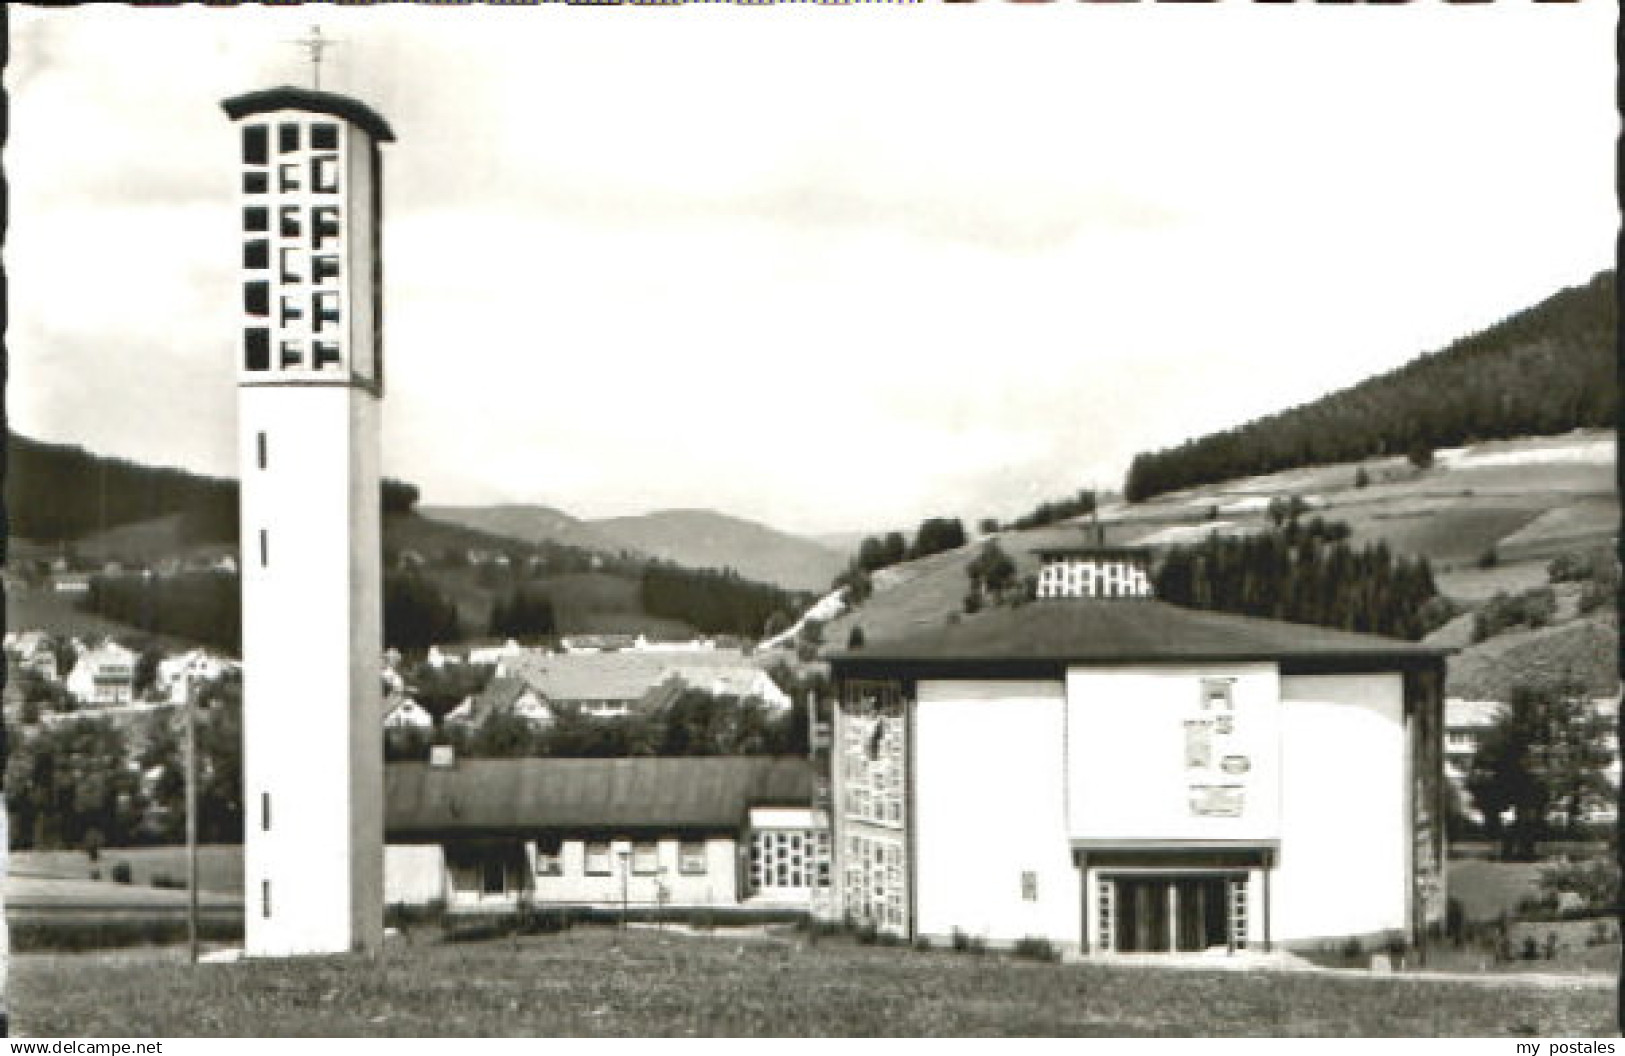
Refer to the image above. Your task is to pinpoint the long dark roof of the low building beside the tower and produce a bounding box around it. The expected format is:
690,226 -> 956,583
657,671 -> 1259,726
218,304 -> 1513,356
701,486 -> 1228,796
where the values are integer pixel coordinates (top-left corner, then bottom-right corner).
384,755 -> 813,840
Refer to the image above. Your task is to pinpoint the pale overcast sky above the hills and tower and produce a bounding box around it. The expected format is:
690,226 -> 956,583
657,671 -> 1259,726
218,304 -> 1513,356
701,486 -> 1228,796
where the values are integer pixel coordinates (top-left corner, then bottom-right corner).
5,0 -> 1619,533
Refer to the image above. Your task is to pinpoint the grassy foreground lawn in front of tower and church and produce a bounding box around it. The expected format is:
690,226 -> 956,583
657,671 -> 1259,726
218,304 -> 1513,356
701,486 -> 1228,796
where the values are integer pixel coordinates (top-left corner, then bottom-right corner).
10,928 -> 1614,1037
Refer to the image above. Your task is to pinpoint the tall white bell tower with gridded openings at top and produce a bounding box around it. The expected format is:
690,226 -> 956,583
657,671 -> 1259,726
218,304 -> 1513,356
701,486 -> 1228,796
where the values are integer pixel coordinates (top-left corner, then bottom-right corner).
221,88 -> 395,957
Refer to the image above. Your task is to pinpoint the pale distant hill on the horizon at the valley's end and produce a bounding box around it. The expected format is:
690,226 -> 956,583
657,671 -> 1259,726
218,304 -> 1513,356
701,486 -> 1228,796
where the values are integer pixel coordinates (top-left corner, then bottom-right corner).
588,510 -> 847,590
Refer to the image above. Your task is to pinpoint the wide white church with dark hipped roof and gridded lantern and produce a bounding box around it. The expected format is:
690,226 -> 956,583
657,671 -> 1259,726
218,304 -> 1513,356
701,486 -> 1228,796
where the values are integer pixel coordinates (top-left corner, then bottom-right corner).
832,549 -> 1445,952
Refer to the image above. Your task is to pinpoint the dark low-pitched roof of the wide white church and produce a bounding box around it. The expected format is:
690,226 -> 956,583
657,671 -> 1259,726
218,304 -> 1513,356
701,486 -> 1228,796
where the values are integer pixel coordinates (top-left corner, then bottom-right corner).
830,598 -> 1450,674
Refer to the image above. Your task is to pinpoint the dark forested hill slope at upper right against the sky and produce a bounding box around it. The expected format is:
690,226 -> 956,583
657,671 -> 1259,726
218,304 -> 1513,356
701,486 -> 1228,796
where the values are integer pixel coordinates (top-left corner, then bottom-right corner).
1125,271 -> 1619,502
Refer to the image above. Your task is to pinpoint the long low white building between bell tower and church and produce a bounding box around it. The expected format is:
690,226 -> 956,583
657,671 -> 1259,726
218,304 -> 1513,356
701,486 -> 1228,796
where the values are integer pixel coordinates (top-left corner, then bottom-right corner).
385,755 -> 830,913
